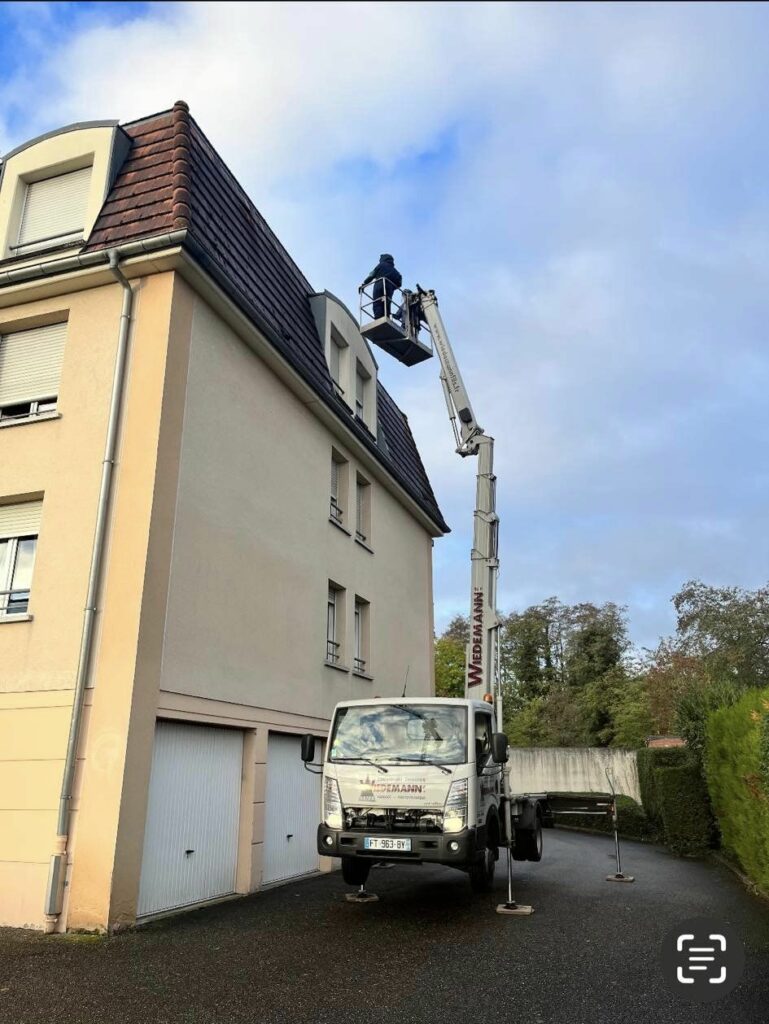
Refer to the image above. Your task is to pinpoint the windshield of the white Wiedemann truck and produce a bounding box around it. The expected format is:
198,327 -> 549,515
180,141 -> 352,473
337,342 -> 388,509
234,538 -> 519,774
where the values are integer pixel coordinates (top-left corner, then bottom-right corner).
329,703 -> 467,765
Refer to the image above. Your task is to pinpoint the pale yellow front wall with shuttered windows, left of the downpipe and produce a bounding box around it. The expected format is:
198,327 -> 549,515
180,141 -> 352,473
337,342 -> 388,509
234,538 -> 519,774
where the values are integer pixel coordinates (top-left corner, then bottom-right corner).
0,286 -> 128,927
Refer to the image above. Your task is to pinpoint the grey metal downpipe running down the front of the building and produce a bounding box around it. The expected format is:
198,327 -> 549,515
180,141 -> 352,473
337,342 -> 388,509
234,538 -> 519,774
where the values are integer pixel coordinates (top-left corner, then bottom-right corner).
42,245 -> 136,933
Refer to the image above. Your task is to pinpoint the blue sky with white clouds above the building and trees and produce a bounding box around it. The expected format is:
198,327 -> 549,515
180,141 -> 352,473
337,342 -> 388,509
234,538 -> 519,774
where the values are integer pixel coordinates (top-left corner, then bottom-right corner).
0,3 -> 769,645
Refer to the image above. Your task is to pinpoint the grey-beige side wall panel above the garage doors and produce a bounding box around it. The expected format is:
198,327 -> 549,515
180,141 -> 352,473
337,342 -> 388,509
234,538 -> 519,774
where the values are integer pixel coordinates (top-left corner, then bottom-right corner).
161,292 -> 432,719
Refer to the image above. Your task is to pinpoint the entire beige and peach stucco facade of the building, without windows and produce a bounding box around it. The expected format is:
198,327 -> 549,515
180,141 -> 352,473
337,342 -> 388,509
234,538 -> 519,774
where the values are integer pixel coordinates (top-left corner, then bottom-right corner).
0,245 -> 437,930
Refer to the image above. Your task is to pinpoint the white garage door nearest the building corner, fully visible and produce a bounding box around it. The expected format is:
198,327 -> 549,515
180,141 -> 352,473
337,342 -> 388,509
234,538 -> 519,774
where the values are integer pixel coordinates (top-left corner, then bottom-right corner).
137,722 -> 243,916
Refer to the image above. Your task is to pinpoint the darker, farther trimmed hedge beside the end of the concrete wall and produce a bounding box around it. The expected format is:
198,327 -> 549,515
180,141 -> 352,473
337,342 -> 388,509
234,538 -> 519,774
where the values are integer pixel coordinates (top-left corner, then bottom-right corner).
638,746 -> 713,856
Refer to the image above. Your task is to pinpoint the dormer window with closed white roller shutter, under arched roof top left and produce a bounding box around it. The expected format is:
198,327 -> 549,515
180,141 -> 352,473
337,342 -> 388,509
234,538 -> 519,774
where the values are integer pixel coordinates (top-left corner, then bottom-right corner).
10,167 -> 91,256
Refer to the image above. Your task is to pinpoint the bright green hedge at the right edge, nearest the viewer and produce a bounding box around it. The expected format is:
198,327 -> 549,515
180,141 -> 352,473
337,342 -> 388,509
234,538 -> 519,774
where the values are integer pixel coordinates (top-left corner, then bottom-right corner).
704,689 -> 769,892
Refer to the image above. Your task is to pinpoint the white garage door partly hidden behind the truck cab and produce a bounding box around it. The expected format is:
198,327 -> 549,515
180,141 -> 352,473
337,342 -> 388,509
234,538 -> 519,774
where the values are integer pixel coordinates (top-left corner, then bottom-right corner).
262,733 -> 321,882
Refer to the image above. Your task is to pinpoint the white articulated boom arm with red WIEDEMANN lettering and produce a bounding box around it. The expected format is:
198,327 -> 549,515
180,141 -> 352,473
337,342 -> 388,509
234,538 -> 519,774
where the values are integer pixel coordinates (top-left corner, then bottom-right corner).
408,287 -> 502,732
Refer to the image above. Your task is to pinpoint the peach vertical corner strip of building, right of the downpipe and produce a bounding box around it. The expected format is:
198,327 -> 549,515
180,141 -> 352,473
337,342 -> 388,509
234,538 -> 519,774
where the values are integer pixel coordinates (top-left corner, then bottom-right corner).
66,273 -> 191,929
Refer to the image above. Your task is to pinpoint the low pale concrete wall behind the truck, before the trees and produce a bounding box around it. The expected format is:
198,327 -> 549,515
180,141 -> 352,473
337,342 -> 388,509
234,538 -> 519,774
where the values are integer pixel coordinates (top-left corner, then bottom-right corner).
508,746 -> 641,804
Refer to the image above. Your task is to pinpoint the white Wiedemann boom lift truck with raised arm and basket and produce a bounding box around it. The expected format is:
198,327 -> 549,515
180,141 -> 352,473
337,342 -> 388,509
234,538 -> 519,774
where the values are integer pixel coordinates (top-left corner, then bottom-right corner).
302,281 -> 552,913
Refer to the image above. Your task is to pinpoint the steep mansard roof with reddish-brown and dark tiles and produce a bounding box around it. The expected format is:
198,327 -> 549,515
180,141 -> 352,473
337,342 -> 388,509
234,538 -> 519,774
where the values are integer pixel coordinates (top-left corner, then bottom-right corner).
87,102 -> 448,531
